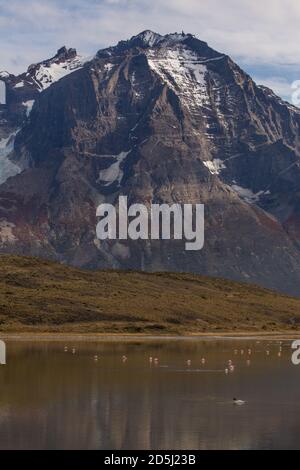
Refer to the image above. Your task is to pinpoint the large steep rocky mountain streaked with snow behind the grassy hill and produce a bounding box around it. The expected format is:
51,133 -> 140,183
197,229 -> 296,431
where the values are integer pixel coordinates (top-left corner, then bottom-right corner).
0,31 -> 300,294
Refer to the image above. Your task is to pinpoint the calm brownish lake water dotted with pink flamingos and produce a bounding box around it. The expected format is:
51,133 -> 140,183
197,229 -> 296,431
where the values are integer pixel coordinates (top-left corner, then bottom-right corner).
0,339 -> 300,450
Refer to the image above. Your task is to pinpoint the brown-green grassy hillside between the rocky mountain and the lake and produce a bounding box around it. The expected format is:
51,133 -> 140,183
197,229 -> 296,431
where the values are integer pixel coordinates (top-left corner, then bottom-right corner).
0,255 -> 300,334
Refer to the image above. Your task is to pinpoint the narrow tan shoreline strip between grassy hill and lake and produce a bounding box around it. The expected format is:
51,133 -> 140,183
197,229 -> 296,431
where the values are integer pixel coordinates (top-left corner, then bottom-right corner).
0,332 -> 300,342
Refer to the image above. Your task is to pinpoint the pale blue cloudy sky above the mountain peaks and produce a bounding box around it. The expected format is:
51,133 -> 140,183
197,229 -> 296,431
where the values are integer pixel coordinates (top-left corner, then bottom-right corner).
0,0 -> 300,100
